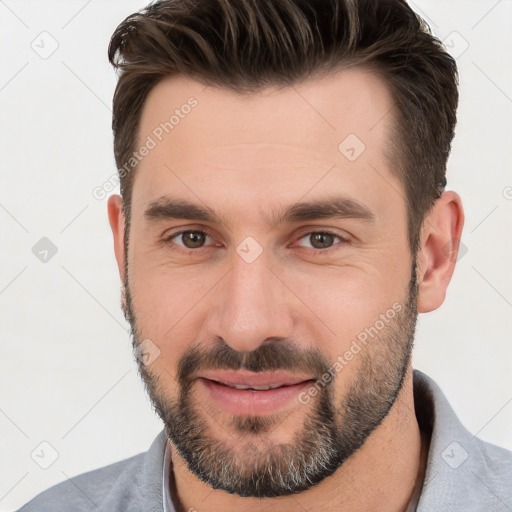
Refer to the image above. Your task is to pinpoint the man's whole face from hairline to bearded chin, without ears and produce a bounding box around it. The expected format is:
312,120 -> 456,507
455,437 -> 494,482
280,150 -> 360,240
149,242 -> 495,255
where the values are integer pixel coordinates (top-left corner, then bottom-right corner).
124,69 -> 417,497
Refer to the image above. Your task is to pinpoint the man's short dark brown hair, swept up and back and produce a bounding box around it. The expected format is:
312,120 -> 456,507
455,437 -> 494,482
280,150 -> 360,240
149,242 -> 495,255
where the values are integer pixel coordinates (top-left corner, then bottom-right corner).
108,0 -> 458,254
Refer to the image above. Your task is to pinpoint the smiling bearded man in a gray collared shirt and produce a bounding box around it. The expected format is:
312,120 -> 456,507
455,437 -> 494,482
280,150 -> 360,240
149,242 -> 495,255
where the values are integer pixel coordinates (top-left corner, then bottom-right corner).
17,0 -> 512,512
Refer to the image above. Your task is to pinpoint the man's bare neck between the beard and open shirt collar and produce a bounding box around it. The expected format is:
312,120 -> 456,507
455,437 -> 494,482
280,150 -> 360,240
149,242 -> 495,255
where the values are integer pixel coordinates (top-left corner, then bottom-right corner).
170,368 -> 428,512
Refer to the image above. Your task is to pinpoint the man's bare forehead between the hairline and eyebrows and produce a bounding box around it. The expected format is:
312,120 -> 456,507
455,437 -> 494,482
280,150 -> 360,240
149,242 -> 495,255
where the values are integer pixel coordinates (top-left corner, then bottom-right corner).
133,68 -> 401,222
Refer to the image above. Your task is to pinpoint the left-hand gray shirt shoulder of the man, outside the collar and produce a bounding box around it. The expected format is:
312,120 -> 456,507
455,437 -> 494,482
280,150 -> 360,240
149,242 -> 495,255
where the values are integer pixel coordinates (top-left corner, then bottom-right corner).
18,453 -> 145,512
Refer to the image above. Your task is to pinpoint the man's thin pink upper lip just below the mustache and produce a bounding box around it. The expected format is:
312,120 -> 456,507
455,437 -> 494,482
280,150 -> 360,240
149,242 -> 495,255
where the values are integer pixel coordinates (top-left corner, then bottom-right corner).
198,370 -> 312,386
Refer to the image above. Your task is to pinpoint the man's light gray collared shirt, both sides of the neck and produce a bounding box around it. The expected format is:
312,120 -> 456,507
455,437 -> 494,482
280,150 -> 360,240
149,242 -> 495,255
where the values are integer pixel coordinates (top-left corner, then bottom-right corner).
19,370 -> 512,512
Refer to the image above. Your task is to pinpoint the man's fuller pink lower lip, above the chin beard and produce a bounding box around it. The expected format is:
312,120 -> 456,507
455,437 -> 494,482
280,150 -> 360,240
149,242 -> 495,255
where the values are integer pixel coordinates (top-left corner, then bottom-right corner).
198,378 -> 313,416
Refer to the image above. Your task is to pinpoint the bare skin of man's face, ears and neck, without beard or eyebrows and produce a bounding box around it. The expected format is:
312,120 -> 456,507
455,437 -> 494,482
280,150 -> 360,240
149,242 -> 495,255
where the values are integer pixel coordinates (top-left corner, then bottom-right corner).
108,69 -> 463,512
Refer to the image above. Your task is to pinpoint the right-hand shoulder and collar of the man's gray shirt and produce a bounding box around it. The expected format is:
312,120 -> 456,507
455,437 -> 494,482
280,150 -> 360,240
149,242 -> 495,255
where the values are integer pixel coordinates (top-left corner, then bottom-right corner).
414,370 -> 512,512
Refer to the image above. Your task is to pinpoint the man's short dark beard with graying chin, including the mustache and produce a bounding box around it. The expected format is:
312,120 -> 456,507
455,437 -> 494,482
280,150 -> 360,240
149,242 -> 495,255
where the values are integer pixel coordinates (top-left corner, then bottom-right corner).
122,258 -> 418,498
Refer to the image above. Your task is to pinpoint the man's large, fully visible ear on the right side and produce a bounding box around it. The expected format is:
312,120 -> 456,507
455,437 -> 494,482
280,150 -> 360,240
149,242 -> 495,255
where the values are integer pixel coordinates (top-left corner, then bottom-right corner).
417,191 -> 464,313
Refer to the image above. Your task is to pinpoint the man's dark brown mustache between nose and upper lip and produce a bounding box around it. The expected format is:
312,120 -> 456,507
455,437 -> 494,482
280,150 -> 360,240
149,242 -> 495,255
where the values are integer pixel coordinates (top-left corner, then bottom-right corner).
177,337 -> 331,385
